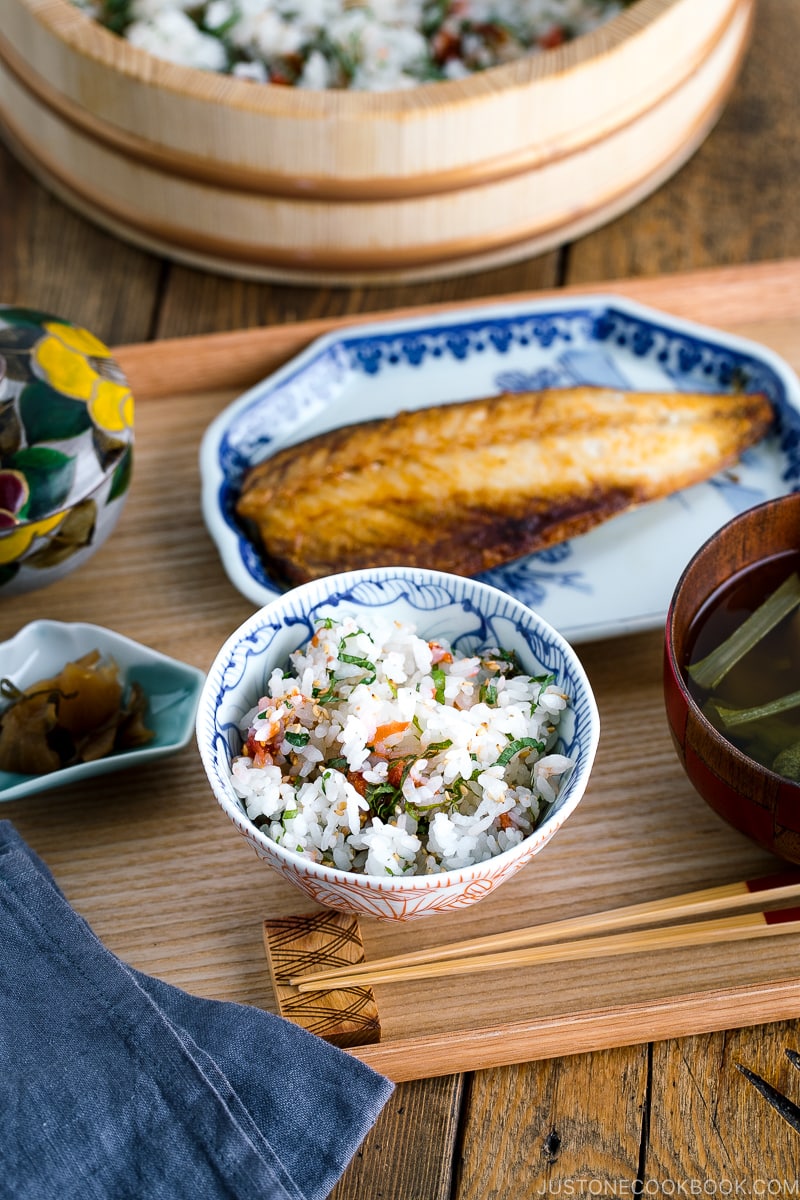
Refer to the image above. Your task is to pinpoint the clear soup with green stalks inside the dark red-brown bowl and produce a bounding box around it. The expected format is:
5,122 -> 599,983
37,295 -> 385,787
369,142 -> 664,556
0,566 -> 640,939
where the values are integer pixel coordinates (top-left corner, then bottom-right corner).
684,551 -> 800,781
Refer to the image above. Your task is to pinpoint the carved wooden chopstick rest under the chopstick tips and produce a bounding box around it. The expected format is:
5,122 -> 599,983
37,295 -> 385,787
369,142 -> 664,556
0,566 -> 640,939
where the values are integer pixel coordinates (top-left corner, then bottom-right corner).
264,911 -> 380,1049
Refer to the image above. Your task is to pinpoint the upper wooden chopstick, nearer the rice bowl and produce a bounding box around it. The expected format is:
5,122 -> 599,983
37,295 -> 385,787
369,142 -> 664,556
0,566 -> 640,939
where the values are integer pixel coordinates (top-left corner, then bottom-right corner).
287,871 -> 800,991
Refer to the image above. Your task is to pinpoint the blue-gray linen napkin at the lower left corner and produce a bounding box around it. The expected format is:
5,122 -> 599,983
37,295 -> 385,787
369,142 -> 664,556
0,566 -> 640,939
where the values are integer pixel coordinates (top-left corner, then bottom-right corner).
0,821 -> 392,1200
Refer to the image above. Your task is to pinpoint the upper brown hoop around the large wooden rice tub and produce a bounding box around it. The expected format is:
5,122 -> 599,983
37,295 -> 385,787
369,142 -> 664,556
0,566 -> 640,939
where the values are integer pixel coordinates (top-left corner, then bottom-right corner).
0,0 -> 739,204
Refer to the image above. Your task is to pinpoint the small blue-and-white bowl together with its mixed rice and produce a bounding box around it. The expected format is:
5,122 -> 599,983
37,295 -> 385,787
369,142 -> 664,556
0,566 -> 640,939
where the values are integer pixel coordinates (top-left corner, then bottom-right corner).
197,566 -> 600,920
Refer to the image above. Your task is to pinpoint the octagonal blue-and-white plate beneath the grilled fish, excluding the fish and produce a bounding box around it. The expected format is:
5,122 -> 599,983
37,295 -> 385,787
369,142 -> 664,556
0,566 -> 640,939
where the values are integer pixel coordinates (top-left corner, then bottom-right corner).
200,295 -> 800,642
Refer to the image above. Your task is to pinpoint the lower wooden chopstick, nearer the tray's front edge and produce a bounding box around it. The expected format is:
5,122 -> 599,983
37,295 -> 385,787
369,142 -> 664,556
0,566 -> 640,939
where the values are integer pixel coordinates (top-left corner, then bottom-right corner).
294,908 -> 800,992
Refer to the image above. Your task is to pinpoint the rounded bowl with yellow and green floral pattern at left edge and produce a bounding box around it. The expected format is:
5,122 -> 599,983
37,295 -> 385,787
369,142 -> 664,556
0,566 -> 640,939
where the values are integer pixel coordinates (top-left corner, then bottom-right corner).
0,305 -> 133,598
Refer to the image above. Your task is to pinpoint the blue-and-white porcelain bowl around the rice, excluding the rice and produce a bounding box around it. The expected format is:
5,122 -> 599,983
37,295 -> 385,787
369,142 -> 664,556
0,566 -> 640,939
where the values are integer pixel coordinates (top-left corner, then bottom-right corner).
197,566 -> 600,920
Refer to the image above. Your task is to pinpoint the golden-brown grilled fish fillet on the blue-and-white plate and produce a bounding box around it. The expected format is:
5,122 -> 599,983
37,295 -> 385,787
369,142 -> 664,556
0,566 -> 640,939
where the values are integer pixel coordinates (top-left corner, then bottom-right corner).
236,386 -> 772,583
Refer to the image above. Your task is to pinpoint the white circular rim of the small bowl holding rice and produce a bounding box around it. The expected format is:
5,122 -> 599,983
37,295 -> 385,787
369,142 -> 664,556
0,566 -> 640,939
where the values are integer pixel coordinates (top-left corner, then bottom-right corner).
196,566 -> 600,893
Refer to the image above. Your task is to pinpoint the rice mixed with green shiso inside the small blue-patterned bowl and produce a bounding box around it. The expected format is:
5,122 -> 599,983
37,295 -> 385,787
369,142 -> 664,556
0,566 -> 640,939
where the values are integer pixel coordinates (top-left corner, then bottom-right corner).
231,614 -> 573,876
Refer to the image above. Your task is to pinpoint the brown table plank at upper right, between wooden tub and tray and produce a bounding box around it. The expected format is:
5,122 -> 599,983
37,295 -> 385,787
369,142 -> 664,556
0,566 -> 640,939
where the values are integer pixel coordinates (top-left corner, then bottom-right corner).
565,0 -> 800,283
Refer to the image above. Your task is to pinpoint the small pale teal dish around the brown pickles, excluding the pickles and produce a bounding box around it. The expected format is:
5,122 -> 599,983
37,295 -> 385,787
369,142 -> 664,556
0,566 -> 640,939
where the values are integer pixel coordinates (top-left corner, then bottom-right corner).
0,620 -> 205,800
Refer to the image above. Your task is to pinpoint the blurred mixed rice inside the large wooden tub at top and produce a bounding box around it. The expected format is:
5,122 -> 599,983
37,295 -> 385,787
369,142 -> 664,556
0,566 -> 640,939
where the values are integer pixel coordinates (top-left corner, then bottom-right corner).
74,0 -> 632,91
